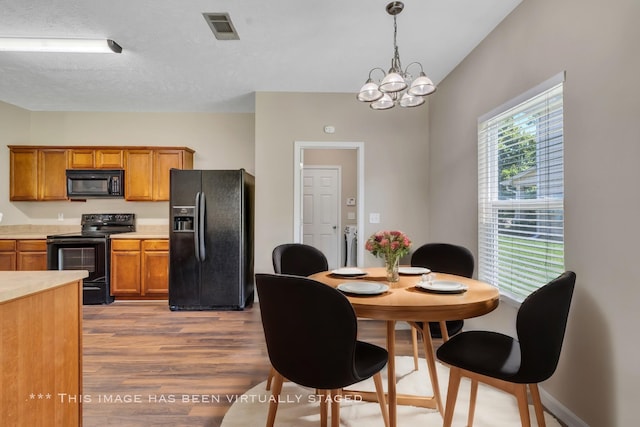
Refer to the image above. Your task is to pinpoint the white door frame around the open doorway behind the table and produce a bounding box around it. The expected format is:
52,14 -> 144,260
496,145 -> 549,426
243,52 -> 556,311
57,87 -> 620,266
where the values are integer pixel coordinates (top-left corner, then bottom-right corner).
293,141 -> 366,266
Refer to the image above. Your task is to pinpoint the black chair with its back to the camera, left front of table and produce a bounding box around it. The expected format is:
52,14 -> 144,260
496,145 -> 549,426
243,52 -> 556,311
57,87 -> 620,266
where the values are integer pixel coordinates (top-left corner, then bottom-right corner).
256,274 -> 389,427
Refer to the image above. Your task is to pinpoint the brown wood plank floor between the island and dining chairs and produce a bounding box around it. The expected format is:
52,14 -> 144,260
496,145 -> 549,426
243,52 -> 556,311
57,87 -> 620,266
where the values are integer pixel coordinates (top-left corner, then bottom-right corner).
83,301 -> 422,427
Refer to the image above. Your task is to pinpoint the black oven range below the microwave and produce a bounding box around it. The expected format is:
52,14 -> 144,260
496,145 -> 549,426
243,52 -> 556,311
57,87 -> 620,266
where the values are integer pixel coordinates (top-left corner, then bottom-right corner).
47,213 -> 136,304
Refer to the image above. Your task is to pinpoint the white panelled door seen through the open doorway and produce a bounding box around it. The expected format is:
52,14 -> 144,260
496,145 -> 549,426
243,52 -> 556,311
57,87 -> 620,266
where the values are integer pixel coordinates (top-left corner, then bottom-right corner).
302,165 -> 341,270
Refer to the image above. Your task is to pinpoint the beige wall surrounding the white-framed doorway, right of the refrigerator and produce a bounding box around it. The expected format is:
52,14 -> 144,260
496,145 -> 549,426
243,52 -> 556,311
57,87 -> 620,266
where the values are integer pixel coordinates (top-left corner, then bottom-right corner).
256,93 -> 428,272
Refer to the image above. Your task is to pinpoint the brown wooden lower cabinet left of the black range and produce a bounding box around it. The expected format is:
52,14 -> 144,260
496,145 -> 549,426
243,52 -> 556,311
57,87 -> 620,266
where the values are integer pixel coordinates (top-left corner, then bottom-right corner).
0,239 -> 47,271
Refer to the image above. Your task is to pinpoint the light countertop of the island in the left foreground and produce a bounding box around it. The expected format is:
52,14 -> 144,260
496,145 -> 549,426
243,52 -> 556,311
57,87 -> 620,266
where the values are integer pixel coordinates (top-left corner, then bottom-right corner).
0,270 -> 89,303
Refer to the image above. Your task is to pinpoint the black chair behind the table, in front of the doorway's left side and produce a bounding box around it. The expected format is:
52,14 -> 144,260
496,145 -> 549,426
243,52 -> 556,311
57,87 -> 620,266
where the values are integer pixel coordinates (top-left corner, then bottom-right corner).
271,243 -> 329,276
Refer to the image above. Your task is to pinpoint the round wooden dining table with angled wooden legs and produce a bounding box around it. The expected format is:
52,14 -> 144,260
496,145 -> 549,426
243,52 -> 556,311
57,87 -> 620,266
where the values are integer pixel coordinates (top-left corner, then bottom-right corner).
309,267 -> 499,427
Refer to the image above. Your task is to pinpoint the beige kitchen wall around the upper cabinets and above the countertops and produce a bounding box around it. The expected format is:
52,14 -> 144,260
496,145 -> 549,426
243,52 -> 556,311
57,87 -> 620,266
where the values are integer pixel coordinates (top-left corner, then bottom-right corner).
0,108 -> 255,225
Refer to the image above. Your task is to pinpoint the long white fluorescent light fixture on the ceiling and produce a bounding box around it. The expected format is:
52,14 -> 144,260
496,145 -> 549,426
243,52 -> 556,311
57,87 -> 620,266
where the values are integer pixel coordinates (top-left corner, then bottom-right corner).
0,37 -> 122,53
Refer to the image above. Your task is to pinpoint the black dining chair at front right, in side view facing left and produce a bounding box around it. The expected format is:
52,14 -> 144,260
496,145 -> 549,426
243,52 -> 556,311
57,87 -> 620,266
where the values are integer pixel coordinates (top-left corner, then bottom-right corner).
436,271 -> 576,427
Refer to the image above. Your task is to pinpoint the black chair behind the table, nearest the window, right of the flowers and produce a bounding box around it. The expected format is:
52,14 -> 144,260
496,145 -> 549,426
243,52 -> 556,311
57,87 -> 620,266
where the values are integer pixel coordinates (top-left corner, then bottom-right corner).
411,243 -> 475,369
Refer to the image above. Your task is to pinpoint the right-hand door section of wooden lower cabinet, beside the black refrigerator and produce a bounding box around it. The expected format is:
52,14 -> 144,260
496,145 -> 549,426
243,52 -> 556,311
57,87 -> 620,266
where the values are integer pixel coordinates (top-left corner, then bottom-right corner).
142,240 -> 169,297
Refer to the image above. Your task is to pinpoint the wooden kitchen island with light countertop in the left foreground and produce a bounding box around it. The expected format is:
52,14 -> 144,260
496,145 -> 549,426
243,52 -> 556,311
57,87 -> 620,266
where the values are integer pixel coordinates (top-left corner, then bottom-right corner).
0,270 -> 88,427
